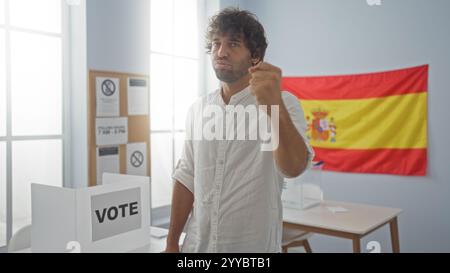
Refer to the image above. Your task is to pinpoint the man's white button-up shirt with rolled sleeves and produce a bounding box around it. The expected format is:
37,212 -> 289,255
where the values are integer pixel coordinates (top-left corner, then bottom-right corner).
173,87 -> 313,252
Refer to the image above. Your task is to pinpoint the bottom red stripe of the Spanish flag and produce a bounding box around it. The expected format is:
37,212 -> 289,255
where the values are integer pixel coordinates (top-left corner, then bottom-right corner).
314,147 -> 427,176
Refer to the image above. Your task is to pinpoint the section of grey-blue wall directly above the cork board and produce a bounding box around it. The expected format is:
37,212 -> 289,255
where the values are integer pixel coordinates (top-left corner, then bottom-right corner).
87,0 -> 150,74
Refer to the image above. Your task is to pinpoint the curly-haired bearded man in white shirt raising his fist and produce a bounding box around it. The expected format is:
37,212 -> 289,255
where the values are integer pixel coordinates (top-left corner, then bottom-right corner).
166,8 -> 313,252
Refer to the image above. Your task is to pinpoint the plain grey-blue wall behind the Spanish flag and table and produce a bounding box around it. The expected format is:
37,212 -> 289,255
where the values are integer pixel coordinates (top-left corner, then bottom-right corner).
221,0 -> 450,252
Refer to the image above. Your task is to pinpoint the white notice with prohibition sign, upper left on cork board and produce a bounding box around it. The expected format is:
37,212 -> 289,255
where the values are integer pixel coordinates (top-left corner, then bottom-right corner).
96,77 -> 120,117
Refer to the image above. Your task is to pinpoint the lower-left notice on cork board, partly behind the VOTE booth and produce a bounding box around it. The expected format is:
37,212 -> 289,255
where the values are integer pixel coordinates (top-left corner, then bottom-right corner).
97,146 -> 120,185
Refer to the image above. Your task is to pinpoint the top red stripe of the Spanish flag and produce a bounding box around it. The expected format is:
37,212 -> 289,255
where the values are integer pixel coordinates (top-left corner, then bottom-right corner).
281,65 -> 428,100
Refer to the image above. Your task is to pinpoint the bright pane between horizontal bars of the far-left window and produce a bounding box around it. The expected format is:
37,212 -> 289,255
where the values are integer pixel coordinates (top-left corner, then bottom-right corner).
10,31 -> 62,136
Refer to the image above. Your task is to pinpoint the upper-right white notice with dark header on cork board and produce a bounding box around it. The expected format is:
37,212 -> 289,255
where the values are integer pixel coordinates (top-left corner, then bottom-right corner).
128,78 -> 148,116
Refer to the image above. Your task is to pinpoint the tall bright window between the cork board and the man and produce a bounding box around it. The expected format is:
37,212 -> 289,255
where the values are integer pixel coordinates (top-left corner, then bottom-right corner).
150,0 -> 202,215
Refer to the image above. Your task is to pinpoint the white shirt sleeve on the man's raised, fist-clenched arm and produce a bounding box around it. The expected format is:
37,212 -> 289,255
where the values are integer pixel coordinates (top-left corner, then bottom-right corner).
282,91 -> 314,173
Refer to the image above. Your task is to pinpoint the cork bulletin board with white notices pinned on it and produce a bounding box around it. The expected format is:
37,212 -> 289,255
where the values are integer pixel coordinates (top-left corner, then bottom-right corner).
88,70 -> 151,186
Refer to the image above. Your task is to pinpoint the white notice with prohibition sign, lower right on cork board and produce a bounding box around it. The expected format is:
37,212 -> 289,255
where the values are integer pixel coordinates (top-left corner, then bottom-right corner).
127,142 -> 147,176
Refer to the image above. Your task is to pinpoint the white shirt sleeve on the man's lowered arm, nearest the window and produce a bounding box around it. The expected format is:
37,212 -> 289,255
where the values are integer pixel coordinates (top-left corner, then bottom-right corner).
172,105 -> 194,193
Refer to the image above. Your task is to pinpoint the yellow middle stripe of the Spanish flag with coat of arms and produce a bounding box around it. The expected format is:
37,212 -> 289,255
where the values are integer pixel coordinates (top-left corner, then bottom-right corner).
301,92 -> 427,149
